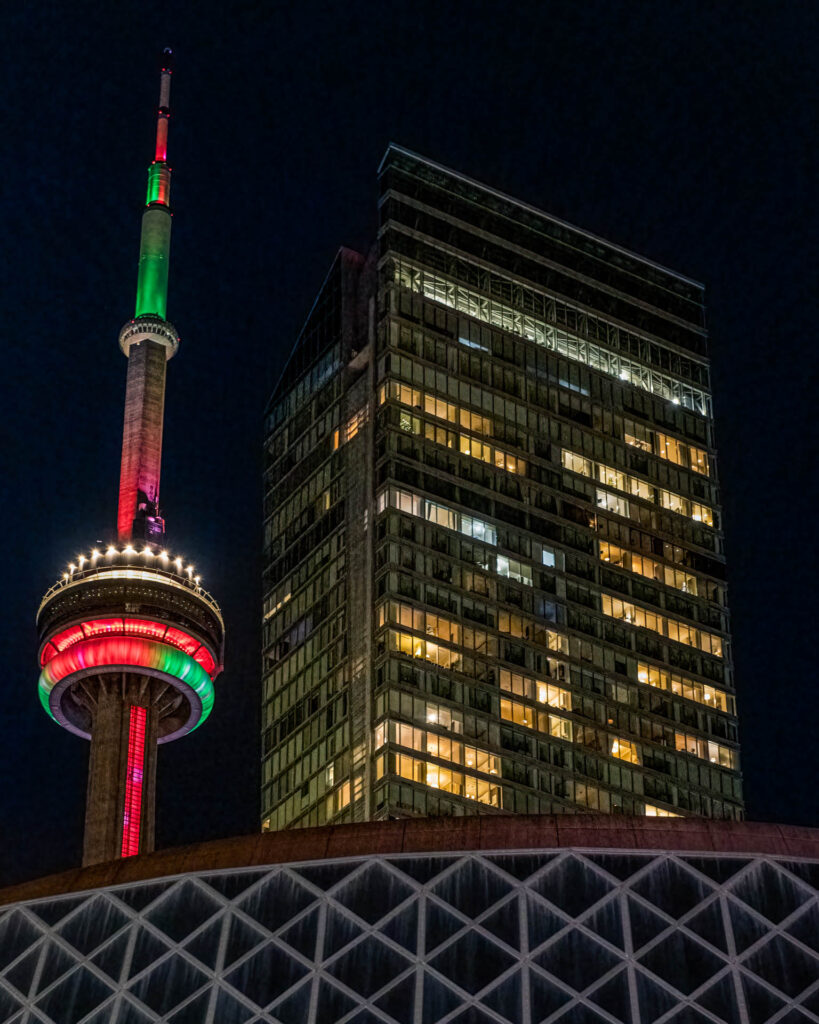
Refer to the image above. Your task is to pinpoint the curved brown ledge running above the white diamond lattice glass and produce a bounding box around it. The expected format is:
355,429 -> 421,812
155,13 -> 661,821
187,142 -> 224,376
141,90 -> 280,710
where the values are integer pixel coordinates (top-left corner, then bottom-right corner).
0,814 -> 819,906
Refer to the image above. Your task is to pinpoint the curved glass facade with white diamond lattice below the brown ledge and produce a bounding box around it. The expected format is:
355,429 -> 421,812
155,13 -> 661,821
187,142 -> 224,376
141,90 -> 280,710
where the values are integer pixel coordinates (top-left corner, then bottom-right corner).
0,850 -> 819,1024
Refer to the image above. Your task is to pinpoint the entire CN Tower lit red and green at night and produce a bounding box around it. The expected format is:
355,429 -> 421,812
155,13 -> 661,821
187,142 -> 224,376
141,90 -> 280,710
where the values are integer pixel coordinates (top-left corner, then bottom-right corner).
37,50 -> 224,864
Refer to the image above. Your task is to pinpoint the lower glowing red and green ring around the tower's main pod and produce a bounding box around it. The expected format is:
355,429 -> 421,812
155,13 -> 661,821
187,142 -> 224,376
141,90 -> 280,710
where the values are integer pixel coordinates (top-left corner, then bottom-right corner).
38,636 -> 213,731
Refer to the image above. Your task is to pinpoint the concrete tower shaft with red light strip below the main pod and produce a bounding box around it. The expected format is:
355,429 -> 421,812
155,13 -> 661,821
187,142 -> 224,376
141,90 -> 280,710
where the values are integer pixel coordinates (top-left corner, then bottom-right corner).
83,673 -> 159,865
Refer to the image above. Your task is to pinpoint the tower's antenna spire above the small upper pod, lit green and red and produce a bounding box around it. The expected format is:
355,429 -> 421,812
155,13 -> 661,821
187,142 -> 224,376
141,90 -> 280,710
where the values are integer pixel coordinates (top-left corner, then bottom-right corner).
135,50 -> 171,319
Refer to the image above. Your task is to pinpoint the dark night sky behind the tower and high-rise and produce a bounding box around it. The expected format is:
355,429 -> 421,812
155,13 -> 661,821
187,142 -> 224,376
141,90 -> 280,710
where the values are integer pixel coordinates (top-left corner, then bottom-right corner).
0,0 -> 819,884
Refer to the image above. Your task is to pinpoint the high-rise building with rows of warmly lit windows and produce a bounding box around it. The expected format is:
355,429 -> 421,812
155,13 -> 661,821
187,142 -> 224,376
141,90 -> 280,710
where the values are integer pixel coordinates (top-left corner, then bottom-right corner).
262,146 -> 742,829
